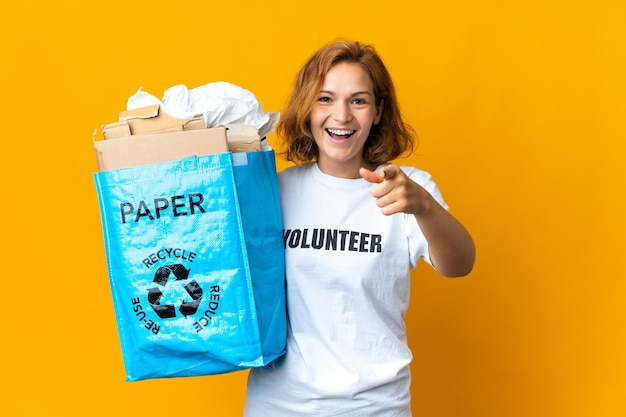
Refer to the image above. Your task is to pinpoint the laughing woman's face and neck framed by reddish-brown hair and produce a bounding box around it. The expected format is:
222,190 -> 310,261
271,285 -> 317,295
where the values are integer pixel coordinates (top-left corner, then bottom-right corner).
310,62 -> 382,178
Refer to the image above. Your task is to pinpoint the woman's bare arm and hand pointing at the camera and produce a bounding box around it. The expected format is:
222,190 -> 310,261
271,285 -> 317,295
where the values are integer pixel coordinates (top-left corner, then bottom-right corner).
360,165 -> 476,277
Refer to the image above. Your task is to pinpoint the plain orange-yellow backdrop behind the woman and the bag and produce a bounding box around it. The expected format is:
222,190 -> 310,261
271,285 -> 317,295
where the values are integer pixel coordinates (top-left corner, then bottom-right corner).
0,0 -> 626,417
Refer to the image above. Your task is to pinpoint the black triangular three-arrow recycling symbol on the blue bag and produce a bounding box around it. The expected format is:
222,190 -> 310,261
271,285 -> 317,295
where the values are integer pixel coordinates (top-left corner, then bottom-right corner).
148,264 -> 202,319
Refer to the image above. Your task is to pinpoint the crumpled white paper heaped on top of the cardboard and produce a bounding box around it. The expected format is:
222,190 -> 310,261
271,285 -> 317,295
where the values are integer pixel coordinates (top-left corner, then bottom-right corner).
126,82 -> 280,138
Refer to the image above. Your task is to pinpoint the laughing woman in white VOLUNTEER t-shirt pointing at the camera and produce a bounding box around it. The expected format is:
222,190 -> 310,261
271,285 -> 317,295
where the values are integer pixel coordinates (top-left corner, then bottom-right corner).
245,41 -> 475,417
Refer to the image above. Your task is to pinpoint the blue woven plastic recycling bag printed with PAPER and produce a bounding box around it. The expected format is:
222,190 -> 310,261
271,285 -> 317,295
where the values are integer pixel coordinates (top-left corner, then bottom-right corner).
94,150 -> 286,381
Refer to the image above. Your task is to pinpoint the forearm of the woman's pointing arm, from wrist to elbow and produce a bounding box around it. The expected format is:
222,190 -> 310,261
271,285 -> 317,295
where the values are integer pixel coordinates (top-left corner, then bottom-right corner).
415,200 -> 476,277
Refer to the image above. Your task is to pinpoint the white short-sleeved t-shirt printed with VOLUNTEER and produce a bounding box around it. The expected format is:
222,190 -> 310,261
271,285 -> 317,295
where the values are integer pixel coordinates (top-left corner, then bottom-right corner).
244,163 -> 446,417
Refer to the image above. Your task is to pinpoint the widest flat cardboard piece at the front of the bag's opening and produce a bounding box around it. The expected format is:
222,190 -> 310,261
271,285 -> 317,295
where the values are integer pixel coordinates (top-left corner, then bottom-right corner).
94,127 -> 229,171
